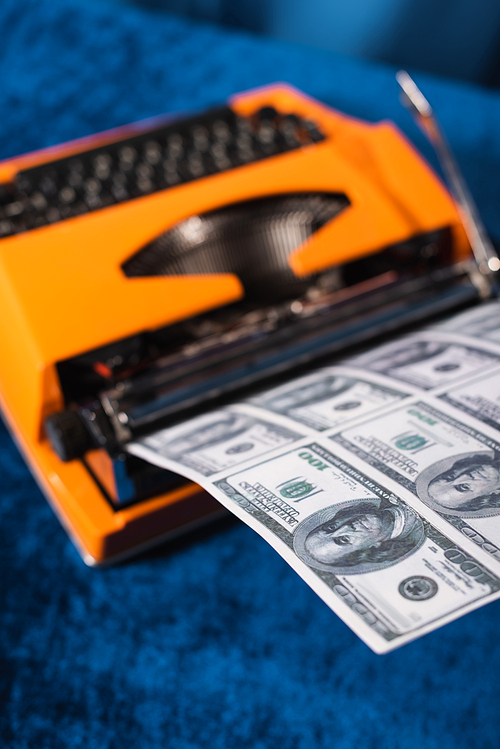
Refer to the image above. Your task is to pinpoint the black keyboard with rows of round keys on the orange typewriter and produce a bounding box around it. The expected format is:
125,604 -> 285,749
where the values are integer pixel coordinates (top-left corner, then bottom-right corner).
0,107 -> 325,238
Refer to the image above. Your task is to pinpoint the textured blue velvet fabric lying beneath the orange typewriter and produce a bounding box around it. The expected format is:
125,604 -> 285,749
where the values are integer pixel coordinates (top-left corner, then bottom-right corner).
0,0 -> 500,749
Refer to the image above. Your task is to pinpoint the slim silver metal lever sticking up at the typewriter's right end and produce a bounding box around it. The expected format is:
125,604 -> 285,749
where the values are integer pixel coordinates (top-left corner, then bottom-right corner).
396,70 -> 500,282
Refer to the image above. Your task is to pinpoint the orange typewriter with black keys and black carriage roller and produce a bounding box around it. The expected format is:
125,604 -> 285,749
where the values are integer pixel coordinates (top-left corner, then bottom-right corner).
0,85 -> 496,564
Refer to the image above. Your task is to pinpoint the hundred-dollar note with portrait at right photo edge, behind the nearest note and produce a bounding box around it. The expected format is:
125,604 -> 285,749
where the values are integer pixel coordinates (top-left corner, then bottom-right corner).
330,401 -> 500,562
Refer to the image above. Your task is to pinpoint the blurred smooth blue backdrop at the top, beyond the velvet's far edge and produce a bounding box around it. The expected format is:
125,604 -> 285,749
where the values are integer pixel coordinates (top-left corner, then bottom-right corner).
101,0 -> 500,88
